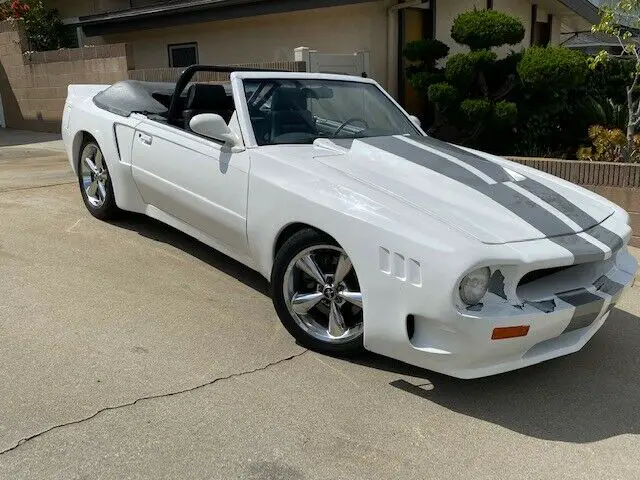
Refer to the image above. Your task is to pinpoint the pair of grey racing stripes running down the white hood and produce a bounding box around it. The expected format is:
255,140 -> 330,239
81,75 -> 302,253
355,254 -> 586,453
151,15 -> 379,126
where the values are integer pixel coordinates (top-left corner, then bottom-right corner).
362,136 -> 624,264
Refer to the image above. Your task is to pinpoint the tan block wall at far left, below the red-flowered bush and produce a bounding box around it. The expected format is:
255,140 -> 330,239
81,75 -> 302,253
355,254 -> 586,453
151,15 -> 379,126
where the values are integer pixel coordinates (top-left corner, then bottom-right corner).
0,22 -> 134,132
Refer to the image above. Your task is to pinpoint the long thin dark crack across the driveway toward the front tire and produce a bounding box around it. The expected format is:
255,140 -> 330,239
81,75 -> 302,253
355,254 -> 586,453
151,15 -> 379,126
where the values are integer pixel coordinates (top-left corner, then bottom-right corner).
0,350 -> 309,456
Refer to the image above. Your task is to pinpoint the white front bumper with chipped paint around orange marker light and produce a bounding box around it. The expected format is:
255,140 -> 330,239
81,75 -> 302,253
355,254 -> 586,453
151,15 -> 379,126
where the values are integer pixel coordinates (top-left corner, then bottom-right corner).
365,244 -> 637,379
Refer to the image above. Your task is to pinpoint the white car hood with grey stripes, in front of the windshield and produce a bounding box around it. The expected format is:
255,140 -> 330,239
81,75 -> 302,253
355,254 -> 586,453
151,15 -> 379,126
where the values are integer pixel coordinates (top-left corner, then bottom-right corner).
313,136 -> 614,244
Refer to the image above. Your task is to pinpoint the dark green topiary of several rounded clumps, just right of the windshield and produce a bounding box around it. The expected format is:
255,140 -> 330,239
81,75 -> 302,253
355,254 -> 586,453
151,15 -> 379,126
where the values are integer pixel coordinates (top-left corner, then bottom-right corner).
405,10 -> 524,146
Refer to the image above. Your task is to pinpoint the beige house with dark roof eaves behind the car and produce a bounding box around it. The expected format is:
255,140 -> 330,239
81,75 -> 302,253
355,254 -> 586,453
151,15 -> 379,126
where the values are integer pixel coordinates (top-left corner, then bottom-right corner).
55,0 -> 598,98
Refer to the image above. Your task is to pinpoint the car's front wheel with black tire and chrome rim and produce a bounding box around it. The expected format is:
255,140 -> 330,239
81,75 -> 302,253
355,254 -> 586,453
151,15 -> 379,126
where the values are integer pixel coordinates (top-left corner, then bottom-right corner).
271,229 -> 364,355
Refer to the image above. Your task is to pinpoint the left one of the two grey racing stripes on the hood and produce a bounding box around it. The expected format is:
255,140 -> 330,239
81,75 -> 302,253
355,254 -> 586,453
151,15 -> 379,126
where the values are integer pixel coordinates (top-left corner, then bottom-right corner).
362,137 -> 605,263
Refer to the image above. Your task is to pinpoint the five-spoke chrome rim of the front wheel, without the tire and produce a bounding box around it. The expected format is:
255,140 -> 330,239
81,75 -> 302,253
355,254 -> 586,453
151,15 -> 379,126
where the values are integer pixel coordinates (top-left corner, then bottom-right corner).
283,245 -> 363,344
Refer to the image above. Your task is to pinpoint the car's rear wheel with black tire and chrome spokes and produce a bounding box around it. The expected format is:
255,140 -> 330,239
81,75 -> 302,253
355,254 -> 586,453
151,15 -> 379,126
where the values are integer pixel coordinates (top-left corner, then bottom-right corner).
78,138 -> 119,220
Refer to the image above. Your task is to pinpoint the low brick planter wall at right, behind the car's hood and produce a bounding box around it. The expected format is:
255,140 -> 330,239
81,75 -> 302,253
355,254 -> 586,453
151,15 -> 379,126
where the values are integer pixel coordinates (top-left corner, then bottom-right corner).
511,157 -> 640,247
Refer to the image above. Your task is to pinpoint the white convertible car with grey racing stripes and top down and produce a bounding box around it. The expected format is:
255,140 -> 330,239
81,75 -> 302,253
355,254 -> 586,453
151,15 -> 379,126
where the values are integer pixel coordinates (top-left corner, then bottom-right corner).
63,66 -> 637,378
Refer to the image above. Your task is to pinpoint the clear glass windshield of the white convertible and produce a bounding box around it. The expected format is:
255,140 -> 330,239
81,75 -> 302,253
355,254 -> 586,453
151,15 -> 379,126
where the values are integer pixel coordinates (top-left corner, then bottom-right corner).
244,79 -> 419,145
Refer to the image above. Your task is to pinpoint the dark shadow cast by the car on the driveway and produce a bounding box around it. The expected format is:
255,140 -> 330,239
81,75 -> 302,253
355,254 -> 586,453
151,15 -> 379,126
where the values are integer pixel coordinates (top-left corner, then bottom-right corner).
107,214 -> 640,443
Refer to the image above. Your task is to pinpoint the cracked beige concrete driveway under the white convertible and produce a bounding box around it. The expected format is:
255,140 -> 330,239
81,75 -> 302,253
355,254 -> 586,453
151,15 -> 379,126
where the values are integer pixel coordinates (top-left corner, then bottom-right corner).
0,141 -> 640,480
